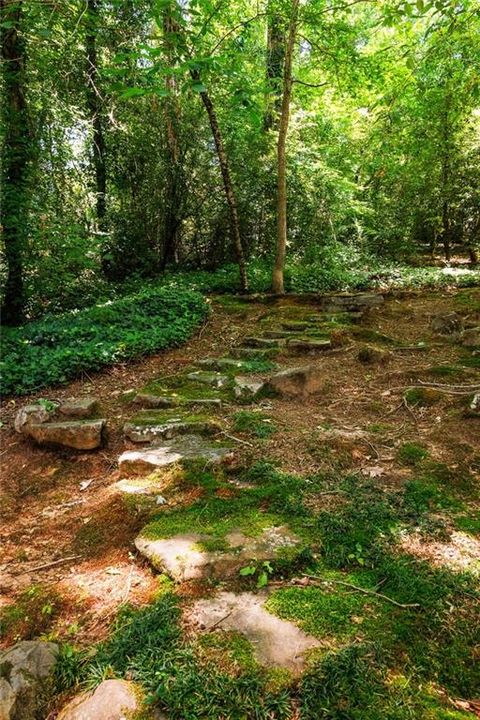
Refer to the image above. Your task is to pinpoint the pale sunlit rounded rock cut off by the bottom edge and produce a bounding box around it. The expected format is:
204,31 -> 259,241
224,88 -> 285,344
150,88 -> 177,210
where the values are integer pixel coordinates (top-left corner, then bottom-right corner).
57,680 -> 143,720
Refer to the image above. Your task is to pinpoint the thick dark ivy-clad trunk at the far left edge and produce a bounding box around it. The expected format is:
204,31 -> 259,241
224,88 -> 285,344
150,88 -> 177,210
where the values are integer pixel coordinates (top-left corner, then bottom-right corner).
0,0 -> 30,325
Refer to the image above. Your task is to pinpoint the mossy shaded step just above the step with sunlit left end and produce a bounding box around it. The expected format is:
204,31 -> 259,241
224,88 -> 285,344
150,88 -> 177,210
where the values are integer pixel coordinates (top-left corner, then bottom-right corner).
123,410 -> 220,443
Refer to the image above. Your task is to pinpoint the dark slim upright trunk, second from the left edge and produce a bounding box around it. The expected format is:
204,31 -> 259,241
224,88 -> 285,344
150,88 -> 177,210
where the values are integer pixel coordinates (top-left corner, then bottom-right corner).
85,0 -> 107,232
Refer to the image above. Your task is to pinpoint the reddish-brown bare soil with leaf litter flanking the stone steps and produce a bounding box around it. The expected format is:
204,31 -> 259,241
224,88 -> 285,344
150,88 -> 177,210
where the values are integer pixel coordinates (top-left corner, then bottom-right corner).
0,290 -> 480,644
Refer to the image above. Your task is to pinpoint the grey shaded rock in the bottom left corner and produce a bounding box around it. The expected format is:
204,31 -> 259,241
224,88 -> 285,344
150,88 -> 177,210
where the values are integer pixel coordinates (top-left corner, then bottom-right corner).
0,640 -> 58,720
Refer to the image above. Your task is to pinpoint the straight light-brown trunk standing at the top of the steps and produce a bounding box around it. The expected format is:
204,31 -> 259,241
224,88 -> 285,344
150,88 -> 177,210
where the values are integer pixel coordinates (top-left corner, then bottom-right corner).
272,0 -> 299,295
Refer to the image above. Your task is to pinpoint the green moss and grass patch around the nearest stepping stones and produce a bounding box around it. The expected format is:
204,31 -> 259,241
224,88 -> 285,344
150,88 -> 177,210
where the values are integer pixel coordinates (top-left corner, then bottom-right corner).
51,458 -> 480,720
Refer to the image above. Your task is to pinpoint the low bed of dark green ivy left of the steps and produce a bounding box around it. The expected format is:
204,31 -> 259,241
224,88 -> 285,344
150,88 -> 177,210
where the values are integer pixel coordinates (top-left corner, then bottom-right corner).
1,287 -> 208,395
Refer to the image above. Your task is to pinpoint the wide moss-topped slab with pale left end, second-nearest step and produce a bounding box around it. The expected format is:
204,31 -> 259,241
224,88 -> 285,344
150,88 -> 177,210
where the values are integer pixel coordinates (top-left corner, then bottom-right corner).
135,520 -> 301,582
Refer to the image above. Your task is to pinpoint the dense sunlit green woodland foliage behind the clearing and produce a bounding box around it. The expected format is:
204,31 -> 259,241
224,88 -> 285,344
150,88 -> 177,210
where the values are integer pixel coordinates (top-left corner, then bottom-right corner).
1,0 -> 480,324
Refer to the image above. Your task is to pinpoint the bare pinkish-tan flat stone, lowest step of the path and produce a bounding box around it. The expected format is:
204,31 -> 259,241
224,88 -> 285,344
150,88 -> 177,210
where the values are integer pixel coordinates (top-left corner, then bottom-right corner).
187,592 -> 320,675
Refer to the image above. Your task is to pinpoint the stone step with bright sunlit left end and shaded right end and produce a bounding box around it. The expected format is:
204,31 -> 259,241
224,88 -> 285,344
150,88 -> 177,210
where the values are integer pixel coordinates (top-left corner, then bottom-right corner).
118,435 -> 234,475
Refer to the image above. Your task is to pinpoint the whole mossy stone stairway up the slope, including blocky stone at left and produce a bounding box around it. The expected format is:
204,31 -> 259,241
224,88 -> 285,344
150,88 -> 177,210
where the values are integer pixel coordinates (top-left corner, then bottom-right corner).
12,295 -> 383,672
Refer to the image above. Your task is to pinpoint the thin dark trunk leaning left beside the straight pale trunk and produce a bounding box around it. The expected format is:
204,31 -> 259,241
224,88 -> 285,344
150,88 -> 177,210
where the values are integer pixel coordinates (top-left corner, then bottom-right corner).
190,70 -> 248,292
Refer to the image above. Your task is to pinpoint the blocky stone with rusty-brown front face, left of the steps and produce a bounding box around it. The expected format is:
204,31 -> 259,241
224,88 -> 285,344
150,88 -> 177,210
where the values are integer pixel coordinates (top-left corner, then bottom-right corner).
23,419 -> 106,450
